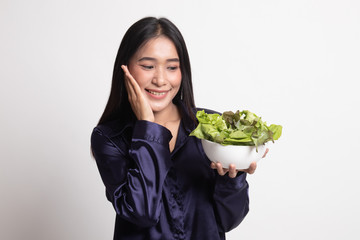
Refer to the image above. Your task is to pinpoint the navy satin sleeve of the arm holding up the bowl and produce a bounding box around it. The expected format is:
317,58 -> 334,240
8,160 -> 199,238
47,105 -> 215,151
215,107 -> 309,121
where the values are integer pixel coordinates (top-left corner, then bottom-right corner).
214,173 -> 249,232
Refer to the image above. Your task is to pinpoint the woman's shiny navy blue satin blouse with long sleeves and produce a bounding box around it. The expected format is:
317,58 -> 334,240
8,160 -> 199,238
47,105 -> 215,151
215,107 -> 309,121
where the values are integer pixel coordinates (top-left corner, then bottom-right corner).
91,106 -> 249,240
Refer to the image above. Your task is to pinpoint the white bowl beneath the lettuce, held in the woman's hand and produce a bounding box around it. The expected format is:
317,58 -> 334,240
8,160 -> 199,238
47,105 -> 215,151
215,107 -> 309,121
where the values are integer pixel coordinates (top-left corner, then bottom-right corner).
201,139 -> 267,169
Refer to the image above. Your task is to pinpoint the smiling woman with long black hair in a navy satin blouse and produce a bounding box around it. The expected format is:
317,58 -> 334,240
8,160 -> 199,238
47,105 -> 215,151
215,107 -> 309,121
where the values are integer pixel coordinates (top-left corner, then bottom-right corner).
91,17 -> 262,240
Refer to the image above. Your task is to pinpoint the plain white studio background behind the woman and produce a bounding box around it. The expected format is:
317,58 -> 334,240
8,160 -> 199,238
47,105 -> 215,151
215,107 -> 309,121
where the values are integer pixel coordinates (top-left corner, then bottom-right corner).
0,0 -> 360,240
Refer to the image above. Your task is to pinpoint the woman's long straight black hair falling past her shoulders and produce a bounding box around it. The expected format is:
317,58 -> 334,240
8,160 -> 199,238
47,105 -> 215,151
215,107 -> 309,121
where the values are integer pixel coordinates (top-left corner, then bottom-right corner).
99,17 -> 195,124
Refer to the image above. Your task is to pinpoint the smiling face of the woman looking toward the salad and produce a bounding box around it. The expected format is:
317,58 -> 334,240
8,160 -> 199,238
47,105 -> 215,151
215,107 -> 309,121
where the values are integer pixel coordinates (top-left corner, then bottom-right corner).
129,36 -> 181,113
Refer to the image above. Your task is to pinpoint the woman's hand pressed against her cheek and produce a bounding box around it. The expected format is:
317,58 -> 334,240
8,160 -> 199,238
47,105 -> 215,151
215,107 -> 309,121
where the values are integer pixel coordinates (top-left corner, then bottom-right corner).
121,65 -> 155,122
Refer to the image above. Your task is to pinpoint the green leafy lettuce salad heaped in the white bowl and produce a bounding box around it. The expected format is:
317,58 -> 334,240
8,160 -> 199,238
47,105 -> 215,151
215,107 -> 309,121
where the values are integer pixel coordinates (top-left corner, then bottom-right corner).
190,110 -> 282,150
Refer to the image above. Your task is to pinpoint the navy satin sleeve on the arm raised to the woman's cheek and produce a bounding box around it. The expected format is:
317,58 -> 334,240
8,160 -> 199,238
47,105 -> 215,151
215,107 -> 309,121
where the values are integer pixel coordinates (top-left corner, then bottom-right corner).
91,121 -> 172,227
